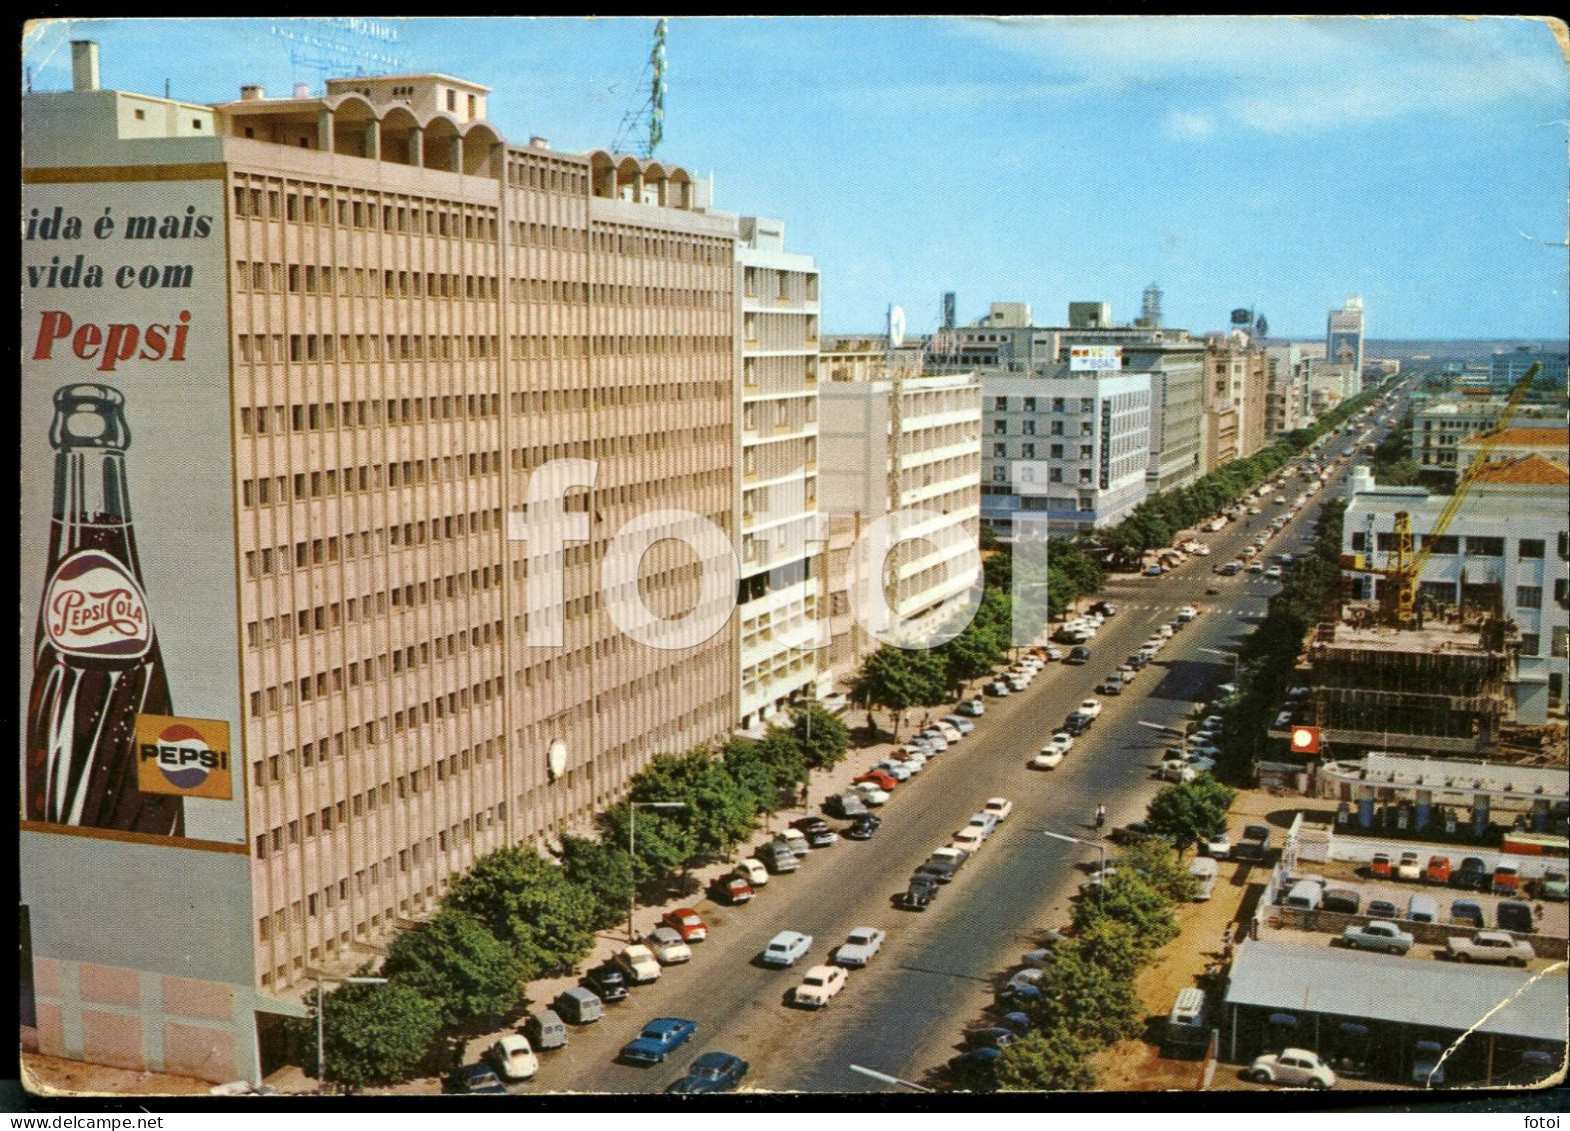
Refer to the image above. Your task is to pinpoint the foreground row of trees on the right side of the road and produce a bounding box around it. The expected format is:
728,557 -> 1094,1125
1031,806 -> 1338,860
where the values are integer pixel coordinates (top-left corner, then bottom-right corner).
958,774 -> 1236,1092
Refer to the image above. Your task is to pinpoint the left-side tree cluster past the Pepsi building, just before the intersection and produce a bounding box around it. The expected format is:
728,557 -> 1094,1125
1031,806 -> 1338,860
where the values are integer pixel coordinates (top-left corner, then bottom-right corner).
851,539 -> 1107,738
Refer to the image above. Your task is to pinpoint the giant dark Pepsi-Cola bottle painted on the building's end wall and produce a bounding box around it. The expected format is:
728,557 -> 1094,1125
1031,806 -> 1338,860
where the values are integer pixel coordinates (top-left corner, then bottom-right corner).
25,385 -> 185,836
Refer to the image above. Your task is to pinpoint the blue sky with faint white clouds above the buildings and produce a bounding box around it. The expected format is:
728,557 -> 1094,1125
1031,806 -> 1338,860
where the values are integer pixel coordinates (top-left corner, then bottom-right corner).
24,17 -> 1570,339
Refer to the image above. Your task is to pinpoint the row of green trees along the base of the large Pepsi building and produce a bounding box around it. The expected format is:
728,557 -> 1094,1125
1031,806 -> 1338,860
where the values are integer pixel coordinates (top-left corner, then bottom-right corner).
295,704 -> 849,1090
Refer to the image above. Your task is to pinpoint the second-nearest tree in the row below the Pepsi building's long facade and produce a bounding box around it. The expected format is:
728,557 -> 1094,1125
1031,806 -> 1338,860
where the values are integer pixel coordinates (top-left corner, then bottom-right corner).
383,908 -> 523,1029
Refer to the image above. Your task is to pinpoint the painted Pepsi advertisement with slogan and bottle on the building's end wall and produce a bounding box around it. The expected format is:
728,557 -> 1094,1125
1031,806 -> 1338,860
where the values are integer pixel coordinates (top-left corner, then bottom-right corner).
20,171 -> 245,844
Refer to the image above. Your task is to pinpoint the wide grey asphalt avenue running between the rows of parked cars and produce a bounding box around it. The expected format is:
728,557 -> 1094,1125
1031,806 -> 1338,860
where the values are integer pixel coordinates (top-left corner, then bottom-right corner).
515,449 -> 1362,1093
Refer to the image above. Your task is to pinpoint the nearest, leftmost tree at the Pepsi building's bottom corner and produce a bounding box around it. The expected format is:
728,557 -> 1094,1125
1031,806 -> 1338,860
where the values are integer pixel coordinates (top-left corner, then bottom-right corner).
294,968 -> 441,1092
